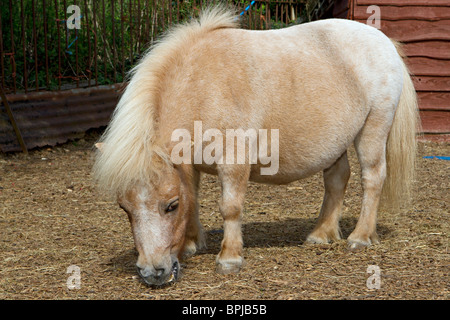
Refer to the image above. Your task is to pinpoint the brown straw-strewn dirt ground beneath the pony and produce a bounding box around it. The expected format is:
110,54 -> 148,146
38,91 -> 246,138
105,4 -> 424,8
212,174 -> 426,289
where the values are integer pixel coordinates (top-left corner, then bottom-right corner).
0,133 -> 450,300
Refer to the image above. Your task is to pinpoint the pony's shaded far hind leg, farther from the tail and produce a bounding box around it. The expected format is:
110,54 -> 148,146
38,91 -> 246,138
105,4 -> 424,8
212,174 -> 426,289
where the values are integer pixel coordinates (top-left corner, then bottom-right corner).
306,152 -> 350,243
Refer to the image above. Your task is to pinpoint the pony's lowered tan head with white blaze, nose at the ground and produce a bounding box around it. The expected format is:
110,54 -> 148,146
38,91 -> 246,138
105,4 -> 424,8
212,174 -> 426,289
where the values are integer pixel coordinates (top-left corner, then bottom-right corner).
96,144 -> 194,286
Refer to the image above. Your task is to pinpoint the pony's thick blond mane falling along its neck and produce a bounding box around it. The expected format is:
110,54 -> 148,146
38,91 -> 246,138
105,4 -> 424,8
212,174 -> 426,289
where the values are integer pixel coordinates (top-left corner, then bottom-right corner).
93,6 -> 238,197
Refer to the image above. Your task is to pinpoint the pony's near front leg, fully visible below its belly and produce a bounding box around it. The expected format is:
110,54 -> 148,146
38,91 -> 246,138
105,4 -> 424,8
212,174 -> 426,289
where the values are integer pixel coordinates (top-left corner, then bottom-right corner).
216,165 -> 250,274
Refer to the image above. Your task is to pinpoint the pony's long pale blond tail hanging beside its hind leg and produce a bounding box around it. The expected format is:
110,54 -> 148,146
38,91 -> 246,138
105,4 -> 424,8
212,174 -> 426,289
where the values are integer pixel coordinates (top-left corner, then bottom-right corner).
383,41 -> 420,208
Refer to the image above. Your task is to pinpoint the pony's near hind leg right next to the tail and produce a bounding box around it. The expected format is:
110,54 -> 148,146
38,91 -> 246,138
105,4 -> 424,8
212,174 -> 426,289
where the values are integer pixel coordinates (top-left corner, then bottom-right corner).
348,110 -> 392,250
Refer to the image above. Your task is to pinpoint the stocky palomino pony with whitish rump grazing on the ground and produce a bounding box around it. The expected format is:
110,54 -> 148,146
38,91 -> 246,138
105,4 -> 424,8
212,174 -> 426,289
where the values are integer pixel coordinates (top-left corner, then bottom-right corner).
93,7 -> 417,285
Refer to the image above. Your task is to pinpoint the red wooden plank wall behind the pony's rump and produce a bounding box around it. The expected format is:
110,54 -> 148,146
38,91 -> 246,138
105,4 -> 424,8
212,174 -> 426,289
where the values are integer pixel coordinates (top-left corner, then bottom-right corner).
346,0 -> 450,134
